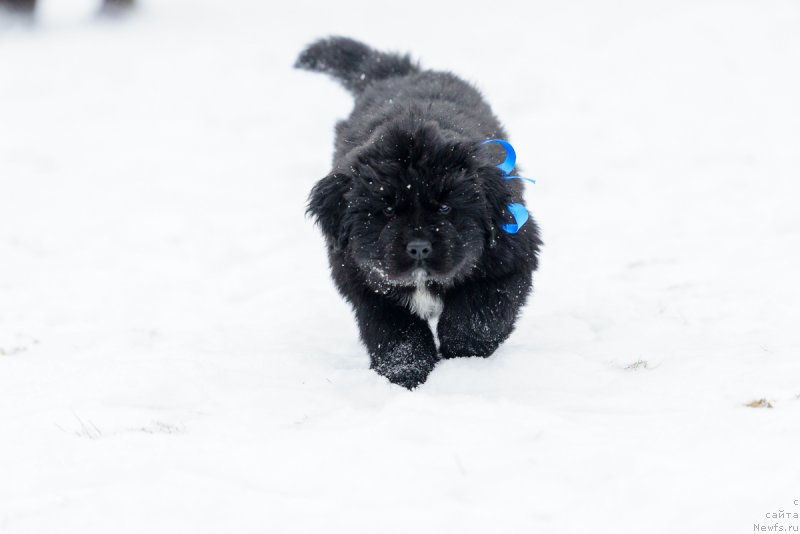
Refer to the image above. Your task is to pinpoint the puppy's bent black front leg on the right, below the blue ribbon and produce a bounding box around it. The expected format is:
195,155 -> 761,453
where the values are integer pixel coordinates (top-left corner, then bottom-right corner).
437,273 -> 531,358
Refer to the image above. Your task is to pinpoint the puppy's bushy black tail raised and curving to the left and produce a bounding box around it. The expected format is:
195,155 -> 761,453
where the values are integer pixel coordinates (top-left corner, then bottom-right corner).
294,37 -> 419,95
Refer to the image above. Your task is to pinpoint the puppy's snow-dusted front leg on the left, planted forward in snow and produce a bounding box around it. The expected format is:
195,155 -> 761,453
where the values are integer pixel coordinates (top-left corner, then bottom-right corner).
356,298 -> 438,389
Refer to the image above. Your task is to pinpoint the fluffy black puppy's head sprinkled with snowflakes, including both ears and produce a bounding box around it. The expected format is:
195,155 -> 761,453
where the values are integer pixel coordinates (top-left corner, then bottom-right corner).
308,123 -> 512,286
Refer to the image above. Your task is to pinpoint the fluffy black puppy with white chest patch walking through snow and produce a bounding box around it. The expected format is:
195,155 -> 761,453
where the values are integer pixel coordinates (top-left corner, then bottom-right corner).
295,37 -> 541,388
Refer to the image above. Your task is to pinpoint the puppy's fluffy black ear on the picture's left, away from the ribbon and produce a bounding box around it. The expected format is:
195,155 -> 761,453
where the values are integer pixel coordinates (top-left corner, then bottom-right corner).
306,173 -> 353,249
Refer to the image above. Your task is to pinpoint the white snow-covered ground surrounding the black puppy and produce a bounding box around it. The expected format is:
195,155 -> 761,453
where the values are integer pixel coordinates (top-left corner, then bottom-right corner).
0,0 -> 800,534
